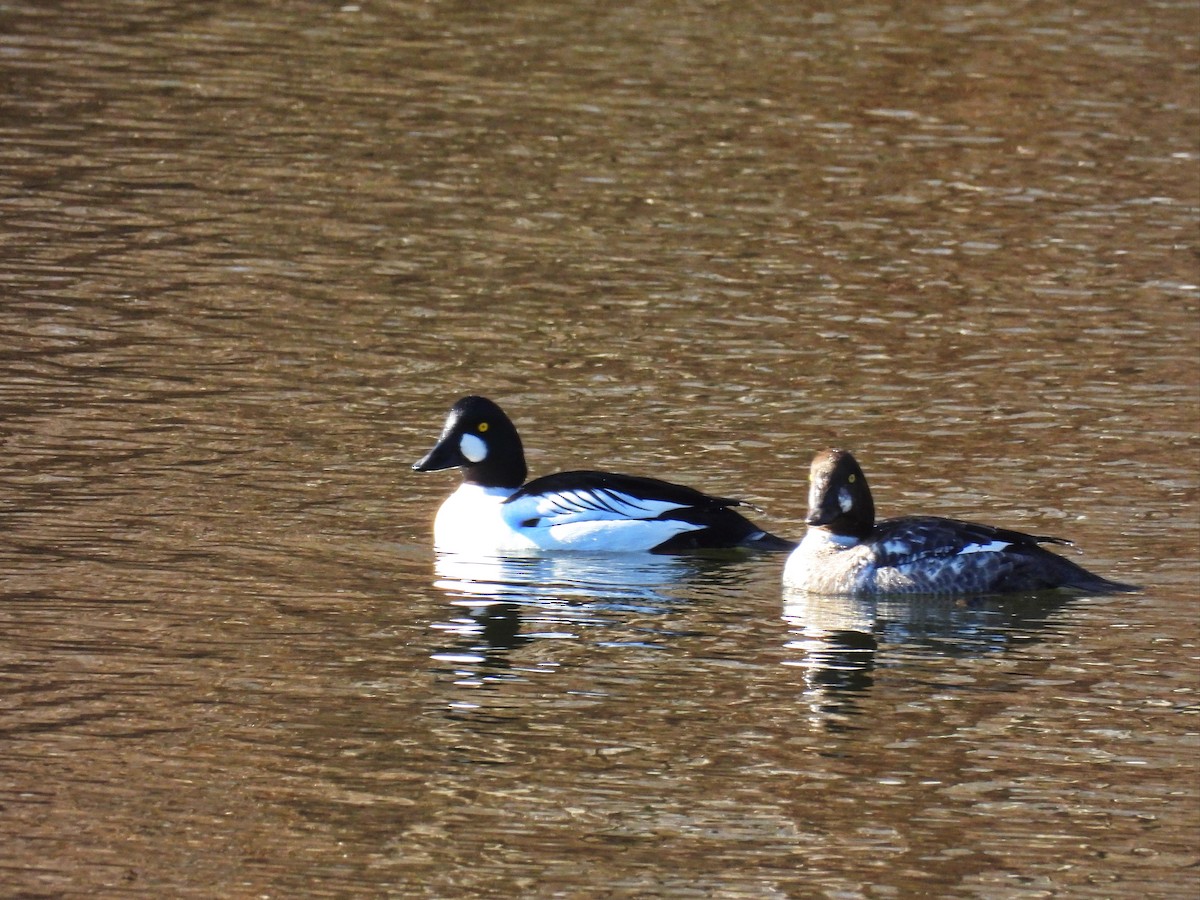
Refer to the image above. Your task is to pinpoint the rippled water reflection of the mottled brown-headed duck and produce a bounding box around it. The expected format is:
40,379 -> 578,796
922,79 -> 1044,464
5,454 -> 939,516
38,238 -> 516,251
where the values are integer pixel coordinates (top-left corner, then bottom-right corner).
784,589 -> 1068,730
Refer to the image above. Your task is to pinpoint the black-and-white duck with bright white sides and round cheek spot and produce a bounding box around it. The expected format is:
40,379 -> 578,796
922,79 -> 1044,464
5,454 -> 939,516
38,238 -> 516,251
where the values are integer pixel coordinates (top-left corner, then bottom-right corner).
413,395 -> 796,556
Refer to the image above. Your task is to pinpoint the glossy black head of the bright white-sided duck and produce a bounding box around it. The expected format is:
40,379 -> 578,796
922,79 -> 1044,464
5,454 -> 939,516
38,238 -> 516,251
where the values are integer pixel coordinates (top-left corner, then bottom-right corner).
413,397 -> 528,487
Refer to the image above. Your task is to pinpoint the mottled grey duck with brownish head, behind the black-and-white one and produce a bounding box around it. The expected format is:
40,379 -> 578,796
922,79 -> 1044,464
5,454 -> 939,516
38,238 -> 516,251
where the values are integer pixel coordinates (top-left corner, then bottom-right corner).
784,449 -> 1138,595
